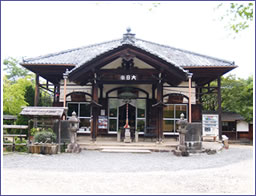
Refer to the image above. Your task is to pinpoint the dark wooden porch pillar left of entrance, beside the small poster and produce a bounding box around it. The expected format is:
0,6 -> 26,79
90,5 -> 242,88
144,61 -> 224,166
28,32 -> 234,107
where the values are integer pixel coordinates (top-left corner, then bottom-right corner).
91,82 -> 99,141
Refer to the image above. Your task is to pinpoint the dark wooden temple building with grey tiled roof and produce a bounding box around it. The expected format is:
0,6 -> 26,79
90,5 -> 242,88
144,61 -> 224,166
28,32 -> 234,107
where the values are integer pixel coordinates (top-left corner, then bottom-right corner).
21,29 -> 237,139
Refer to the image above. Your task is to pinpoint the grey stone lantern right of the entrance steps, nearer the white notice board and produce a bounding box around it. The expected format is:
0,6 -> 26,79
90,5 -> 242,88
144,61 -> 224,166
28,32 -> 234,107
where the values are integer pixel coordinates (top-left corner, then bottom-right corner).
177,113 -> 188,155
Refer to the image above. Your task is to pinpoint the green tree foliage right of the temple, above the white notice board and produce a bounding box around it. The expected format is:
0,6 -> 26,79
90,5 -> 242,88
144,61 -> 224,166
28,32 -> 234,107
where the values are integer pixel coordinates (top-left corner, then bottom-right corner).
202,75 -> 253,122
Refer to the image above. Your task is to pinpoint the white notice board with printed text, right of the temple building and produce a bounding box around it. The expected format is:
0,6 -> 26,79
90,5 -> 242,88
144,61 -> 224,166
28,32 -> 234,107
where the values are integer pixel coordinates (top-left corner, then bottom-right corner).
202,114 -> 219,137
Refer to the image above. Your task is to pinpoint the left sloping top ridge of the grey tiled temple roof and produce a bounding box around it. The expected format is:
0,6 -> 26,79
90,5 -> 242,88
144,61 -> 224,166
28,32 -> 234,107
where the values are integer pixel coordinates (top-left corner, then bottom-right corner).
23,39 -> 122,63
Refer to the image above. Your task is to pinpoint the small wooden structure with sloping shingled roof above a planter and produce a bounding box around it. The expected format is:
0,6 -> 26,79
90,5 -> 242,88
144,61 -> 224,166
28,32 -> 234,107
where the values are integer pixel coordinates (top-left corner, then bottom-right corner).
20,107 -> 67,152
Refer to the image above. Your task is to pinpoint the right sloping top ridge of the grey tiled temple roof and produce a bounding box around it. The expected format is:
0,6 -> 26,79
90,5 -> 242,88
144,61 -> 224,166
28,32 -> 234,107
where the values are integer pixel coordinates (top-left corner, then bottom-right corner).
136,38 -> 235,65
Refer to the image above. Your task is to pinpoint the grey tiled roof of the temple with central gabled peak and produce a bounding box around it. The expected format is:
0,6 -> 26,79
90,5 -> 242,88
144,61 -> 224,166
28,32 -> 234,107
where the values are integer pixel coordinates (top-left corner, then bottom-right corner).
23,33 -> 234,71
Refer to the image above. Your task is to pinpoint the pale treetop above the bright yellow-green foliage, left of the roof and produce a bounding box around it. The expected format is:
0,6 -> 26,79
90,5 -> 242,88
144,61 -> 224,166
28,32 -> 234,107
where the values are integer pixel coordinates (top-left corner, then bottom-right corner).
3,57 -> 32,83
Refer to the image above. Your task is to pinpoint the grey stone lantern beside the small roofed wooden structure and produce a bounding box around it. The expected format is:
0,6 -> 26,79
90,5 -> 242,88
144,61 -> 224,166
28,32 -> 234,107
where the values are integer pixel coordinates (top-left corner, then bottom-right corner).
66,112 -> 81,153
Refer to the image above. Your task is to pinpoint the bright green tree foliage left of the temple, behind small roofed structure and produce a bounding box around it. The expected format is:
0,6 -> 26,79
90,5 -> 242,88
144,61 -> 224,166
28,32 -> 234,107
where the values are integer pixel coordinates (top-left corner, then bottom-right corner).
3,57 -> 52,118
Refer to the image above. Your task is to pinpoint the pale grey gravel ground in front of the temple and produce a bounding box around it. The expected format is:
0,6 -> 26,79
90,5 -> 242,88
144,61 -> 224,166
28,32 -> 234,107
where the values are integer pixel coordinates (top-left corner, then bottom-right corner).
1,145 -> 255,195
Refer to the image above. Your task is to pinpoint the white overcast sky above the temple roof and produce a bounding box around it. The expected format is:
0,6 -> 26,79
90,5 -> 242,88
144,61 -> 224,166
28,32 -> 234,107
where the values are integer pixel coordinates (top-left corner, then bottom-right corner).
1,1 -> 255,78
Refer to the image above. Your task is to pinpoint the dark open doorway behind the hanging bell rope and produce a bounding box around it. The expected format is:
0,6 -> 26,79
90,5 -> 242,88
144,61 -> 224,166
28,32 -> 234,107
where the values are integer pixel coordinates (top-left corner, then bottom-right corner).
118,104 -> 136,129
